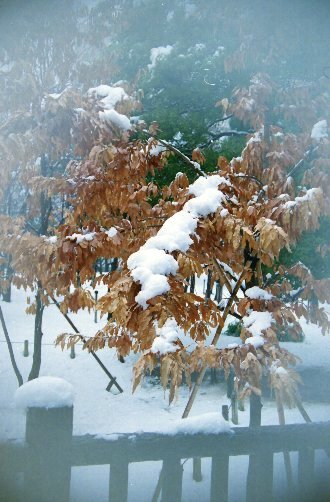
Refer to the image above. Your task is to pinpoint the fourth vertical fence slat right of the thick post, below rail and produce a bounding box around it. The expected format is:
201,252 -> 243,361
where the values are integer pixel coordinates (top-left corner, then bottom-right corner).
246,448 -> 273,502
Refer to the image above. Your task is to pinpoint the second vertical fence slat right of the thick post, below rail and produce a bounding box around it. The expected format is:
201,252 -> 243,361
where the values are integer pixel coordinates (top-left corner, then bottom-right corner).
161,457 -> 183,502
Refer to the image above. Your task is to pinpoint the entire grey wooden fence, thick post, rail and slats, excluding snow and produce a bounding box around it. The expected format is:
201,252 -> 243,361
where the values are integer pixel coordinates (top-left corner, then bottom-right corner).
0,406 -> 330,502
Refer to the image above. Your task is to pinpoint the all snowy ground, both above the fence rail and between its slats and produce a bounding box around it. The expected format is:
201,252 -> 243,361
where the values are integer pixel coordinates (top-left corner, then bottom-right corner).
0,289 -> 330,502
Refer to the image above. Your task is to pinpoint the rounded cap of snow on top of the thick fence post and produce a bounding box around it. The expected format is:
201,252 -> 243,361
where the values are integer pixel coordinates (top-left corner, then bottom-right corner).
14,376 -> 73,409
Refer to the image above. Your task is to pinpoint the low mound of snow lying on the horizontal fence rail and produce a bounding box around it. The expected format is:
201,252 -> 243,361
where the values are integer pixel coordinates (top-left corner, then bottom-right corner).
160,412 -> 233,436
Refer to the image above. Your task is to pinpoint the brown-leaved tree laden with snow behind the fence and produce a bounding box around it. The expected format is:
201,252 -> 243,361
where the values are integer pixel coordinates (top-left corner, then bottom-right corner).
54,75 -> 329,413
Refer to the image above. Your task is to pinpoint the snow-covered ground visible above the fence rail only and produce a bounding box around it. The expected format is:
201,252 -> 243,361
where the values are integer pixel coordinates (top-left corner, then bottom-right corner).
0,289 -> 330,439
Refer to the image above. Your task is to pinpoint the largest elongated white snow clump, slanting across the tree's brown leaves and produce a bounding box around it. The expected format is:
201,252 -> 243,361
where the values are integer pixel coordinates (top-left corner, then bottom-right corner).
127,175 -> 229,308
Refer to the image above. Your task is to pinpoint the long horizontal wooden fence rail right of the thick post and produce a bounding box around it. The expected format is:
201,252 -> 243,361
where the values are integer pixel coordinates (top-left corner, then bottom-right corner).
72,422 -> 330,466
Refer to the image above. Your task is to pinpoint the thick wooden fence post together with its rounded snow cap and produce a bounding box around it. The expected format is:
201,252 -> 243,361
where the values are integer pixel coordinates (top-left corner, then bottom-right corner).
20,377 -> 73,501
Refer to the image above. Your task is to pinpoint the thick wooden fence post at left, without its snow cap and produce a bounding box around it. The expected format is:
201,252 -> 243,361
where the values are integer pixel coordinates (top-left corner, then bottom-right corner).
24,406 -> 73,502
